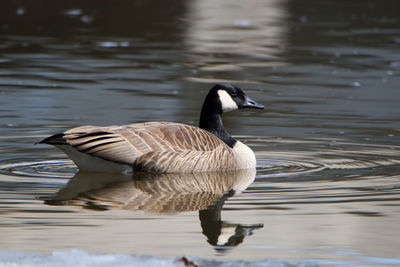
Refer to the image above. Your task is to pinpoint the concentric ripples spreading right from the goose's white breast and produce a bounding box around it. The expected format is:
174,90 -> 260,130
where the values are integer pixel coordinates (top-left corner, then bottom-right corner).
244,137 -> 400,178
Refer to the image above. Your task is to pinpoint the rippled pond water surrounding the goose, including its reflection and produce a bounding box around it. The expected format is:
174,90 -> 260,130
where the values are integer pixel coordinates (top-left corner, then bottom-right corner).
0,0 -> 400,266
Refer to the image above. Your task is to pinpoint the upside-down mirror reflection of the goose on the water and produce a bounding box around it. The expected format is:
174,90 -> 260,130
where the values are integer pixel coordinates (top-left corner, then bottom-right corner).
45,169 -> 263,251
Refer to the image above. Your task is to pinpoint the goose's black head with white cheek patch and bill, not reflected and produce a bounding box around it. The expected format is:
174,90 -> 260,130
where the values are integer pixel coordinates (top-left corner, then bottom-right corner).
206,83 -> 264,114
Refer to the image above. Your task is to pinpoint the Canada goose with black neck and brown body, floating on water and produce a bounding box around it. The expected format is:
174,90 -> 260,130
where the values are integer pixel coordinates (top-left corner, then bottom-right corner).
39,83 -> 264,173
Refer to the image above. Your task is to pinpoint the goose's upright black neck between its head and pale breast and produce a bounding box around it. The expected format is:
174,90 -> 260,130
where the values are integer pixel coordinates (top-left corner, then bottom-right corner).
199,92 -> 236,147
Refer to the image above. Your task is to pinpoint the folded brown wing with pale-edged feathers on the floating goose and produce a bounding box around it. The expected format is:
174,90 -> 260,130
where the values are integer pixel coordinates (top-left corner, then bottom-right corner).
57,122 -> 231,172
